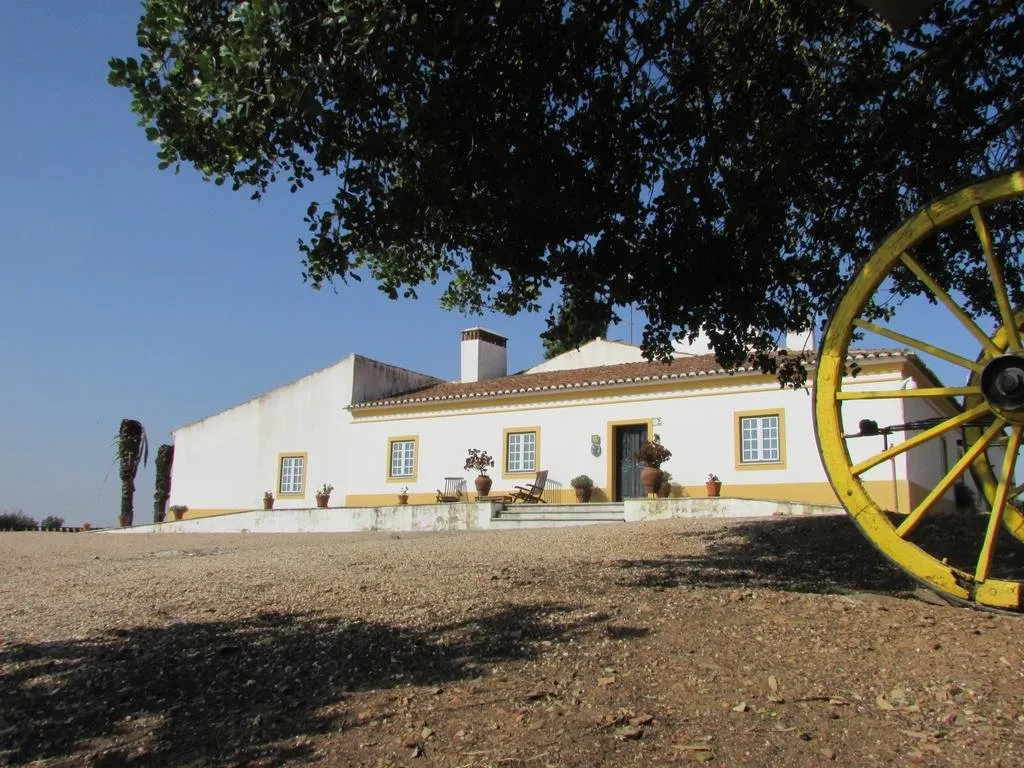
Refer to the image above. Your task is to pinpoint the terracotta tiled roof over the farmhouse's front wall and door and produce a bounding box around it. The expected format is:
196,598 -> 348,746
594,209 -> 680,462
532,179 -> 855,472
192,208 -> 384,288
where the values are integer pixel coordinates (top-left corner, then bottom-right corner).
350,348 -> 909,411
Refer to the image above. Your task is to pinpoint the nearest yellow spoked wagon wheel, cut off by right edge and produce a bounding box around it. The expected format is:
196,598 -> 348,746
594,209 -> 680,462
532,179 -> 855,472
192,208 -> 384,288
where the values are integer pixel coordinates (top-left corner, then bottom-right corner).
814,170 -> 1024,610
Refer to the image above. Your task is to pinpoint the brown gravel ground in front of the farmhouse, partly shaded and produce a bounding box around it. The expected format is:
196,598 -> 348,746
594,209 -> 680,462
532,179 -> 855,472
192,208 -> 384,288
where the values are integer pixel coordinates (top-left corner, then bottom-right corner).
0,517 -> 1024,768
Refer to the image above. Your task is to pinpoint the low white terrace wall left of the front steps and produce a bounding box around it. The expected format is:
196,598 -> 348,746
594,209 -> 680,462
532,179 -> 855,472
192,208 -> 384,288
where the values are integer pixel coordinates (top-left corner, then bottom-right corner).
116,502 -> 501,534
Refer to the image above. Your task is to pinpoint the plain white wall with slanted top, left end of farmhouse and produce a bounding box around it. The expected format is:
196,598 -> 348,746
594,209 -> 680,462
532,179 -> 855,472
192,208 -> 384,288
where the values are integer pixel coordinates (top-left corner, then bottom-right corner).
169,355 -> 437,512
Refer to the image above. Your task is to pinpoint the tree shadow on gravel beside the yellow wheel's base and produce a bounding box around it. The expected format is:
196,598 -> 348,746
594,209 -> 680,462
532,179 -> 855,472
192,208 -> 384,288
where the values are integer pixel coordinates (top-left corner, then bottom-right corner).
620,516 -> 916,594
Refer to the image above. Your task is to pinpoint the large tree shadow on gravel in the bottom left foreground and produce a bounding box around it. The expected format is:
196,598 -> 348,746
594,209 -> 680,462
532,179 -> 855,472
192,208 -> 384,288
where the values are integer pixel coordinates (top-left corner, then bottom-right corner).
0,604 -> 603,766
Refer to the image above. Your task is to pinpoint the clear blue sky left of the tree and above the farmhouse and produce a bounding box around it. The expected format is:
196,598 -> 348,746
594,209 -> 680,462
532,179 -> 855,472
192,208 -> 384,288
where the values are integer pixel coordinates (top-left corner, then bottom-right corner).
0,0 -> 598,525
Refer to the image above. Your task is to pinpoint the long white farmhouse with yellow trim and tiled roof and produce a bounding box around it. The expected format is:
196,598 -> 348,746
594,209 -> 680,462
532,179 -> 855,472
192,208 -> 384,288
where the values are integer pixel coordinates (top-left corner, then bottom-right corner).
171,328 -> 957,517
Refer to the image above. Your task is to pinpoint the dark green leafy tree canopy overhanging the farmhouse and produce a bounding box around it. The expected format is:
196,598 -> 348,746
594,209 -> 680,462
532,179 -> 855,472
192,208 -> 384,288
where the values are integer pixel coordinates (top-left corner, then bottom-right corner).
110,0 -> 1024,385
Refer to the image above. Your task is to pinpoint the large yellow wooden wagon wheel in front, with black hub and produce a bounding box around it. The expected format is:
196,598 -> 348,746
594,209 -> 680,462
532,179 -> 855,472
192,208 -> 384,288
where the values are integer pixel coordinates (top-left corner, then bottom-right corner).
814,170 -> 1024,610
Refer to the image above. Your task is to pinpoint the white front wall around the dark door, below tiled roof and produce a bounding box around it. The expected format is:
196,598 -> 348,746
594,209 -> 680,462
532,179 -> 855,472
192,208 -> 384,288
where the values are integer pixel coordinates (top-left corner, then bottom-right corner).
351,366 -> 906,505
